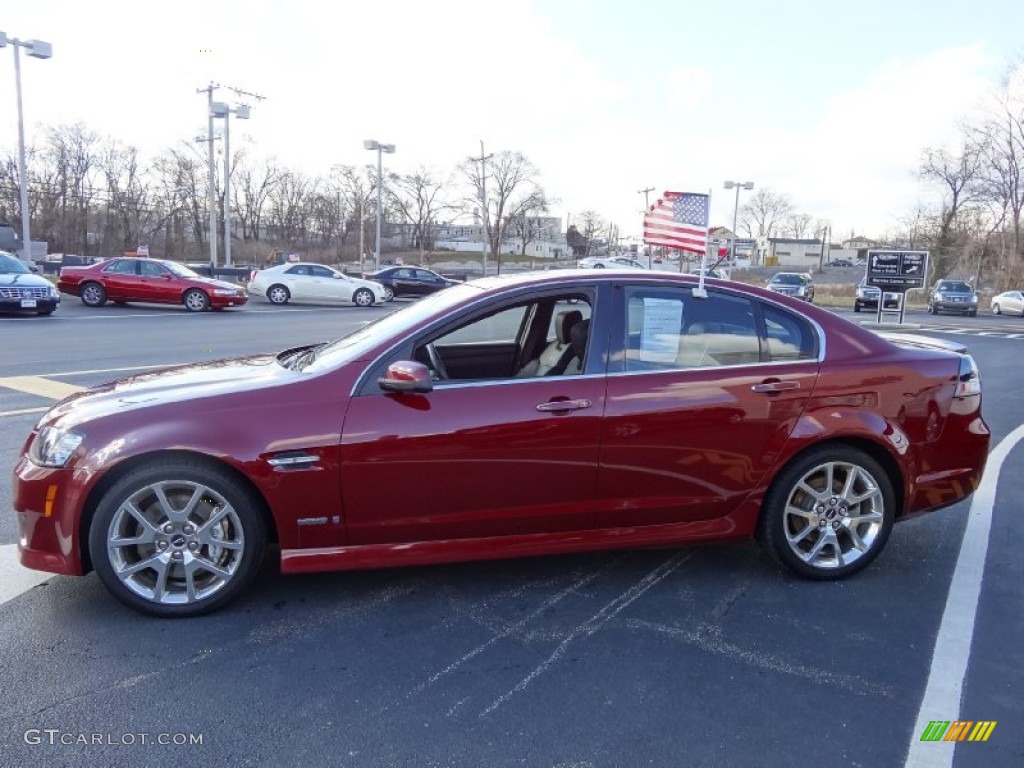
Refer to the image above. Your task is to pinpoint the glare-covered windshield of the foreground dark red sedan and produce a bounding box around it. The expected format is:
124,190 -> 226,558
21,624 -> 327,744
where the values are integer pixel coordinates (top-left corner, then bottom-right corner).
303,283 -> 480,373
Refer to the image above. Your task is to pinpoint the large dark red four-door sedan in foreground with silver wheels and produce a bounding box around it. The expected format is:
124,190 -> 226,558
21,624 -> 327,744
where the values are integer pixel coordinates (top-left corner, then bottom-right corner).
13,269 -> 989,616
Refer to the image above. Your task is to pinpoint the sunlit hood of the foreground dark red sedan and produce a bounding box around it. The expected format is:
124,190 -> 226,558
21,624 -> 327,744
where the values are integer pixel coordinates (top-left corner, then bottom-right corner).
39,347 -> 306,428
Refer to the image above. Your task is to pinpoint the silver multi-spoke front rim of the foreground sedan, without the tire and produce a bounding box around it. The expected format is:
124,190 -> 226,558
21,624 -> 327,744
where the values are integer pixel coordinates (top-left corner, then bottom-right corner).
106,480 -> 246,605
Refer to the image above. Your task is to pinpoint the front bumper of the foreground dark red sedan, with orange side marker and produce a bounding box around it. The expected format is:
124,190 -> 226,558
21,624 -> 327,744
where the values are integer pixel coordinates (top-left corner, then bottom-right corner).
12,456 -> 96,575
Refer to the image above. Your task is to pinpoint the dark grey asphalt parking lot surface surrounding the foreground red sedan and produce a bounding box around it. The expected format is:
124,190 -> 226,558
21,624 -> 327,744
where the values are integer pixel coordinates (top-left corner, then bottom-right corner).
0,298 -> 1024,768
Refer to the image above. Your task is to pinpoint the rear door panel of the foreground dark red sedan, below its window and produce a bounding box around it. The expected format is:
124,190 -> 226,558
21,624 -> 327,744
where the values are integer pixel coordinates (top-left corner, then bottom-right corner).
596,361 -> 818,527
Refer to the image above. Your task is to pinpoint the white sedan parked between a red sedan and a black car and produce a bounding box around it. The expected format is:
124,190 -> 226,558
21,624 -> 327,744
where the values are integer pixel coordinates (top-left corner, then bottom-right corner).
249,261 -> 385,306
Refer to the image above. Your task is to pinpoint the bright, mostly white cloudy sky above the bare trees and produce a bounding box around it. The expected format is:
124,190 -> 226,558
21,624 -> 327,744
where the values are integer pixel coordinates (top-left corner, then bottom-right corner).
0,0 -> 1024,240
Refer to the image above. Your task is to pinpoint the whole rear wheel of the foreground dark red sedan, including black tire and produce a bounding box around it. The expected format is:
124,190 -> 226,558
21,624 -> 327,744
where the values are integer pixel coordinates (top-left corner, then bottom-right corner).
758,444 -> 896,581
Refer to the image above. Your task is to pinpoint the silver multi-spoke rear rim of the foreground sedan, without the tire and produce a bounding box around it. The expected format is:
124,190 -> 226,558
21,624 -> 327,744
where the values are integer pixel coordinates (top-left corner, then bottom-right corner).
783,462 -> 885,570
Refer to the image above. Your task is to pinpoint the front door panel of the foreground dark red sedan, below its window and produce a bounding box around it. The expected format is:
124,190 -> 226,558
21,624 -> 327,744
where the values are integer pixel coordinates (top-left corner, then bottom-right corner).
342,377 -> 605,544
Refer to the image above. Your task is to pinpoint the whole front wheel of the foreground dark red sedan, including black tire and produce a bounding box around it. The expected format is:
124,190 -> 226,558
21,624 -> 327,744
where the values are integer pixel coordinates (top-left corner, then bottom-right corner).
88,459 -> 266,618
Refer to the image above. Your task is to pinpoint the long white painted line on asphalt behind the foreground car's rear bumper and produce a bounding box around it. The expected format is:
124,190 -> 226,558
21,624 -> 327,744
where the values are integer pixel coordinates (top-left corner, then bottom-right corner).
904,424 -> 1024,768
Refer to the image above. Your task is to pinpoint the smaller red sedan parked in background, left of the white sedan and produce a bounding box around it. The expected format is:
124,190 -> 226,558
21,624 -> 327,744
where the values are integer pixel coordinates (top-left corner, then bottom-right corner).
57,256 -> 249,312
